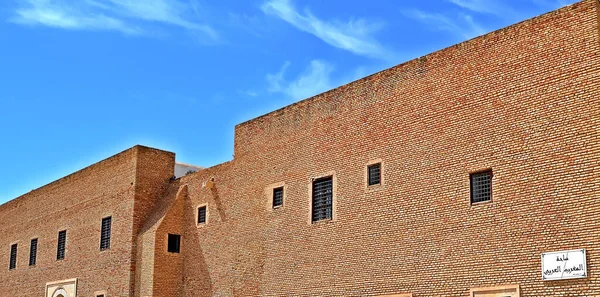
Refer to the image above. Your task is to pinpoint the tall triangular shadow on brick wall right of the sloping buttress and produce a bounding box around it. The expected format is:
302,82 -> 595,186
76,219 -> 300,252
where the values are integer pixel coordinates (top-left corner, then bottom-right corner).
183,193 -> 214,297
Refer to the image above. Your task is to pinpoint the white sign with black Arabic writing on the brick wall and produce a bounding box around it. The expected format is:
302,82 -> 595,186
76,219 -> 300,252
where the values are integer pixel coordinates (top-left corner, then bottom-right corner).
542,249 -> 587,281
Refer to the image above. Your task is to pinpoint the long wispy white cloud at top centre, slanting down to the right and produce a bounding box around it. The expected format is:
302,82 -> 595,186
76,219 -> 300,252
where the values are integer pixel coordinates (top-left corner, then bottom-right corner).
261,0 -> 395,60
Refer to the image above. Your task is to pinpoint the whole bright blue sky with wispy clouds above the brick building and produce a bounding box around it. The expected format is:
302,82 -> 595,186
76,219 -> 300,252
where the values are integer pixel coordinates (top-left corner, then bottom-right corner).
0,0 -> 577,203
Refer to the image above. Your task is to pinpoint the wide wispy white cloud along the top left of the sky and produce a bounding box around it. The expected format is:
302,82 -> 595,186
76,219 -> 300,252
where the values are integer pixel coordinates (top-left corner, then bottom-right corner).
10,0 -> 218,39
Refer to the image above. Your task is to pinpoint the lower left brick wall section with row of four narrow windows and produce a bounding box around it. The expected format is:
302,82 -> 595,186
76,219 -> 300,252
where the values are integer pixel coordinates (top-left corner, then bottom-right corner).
0,146 -> 174,296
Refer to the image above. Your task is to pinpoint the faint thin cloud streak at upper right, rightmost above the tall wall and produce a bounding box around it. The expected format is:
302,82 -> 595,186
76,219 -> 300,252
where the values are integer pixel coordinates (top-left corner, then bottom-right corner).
403,9 -> 487,39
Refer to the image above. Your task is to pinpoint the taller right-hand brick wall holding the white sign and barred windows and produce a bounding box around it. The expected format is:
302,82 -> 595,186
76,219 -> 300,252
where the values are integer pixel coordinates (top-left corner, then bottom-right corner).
181,0 -> 600,297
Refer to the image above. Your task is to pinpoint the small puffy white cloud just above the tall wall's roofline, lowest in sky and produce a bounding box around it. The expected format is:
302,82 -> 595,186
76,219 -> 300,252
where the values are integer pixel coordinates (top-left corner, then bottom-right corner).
267,60 -> 336,100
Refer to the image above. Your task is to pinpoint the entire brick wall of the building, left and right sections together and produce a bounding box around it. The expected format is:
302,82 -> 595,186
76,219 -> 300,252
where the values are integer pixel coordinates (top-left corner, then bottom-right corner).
0,0 -> 600,297
